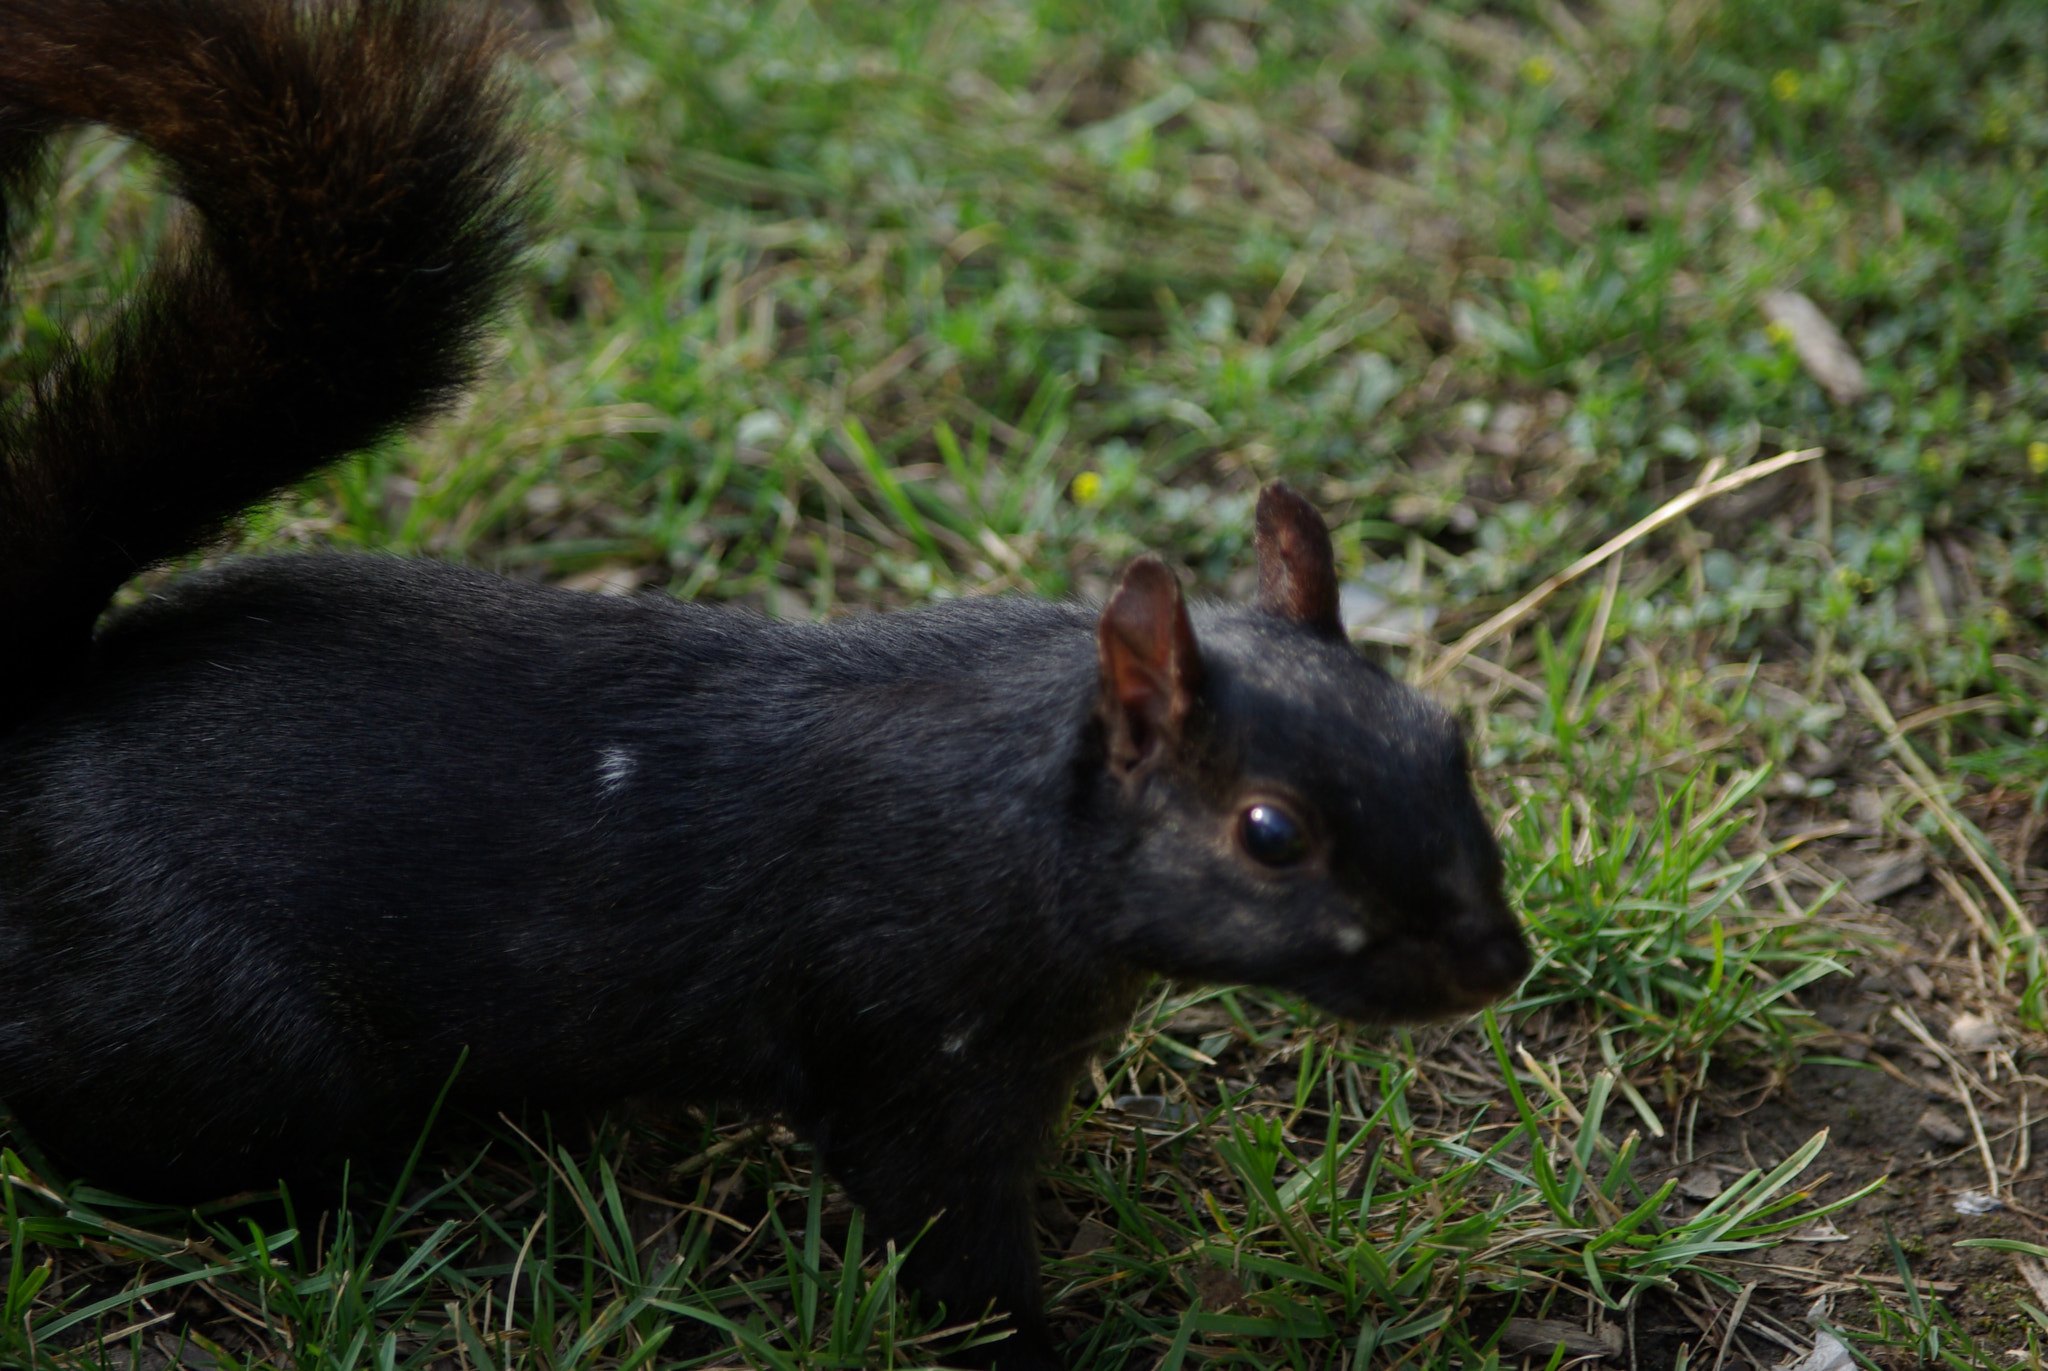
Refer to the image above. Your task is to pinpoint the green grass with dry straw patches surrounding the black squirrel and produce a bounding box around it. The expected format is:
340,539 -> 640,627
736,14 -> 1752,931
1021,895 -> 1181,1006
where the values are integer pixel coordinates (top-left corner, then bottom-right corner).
0,0 -> 2048,1371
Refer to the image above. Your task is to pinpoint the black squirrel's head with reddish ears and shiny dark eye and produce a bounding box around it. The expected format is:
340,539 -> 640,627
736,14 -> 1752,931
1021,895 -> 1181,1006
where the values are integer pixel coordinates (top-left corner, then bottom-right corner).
1096,482 -> 1530,1023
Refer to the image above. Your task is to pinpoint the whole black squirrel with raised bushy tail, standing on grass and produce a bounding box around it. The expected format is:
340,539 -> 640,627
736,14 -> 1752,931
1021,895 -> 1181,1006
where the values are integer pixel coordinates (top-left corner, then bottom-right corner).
0,0 -> 1528,1371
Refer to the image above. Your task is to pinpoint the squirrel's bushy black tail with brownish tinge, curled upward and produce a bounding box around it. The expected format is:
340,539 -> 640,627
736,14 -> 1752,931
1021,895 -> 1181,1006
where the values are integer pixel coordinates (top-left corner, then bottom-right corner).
0,0 -> 535,713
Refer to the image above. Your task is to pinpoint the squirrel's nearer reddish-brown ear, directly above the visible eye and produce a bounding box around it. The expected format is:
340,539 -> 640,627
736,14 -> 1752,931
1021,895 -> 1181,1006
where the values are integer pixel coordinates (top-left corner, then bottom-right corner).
1096,557 -> 1202,777
